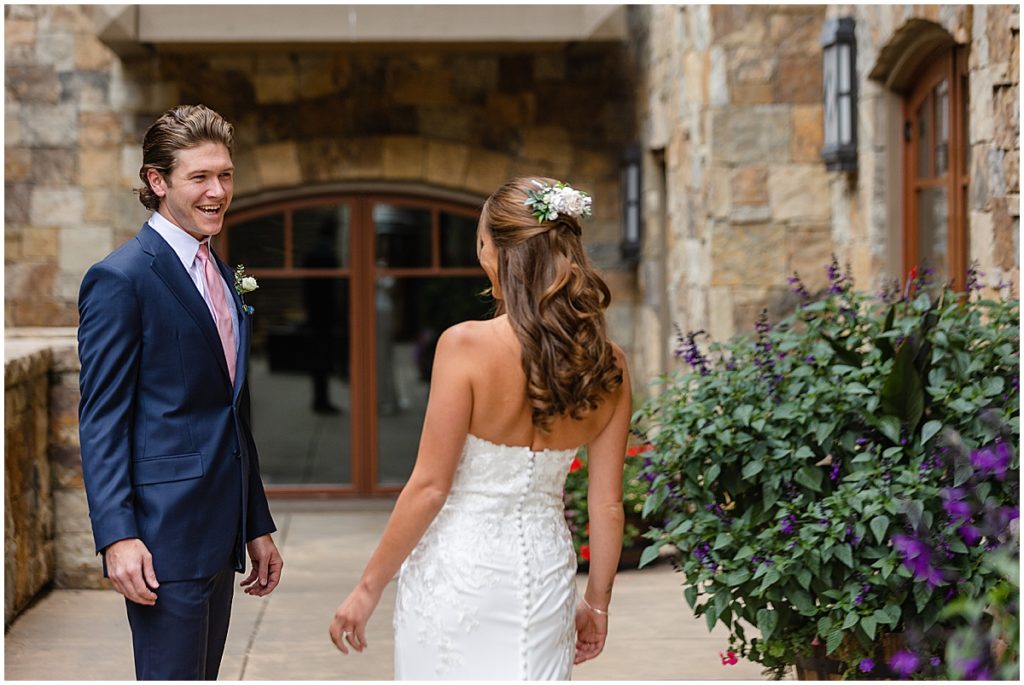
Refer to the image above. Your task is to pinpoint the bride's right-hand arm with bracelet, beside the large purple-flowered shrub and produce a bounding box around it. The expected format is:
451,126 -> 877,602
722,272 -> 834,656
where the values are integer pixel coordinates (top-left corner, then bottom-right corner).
575,347 -> 633,663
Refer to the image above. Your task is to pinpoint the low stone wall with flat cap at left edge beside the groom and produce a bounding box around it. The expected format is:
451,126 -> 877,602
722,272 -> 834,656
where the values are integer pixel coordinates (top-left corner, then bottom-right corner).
4,329 -> 109,624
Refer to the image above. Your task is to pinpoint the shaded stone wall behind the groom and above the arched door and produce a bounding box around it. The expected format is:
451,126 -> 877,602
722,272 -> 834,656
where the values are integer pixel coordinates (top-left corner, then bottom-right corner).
4,5 -> 635,356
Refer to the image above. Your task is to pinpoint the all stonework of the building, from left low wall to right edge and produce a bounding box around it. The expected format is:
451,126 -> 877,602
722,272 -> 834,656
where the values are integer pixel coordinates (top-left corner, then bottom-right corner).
4,5 -> 1020,602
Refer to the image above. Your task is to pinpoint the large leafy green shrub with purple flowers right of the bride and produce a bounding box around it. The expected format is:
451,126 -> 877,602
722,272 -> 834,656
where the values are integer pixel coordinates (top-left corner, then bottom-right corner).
635,260 -> 1020,679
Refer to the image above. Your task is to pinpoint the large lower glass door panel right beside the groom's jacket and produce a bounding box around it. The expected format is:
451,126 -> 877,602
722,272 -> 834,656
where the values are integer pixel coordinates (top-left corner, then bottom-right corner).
247,276 -> 352,485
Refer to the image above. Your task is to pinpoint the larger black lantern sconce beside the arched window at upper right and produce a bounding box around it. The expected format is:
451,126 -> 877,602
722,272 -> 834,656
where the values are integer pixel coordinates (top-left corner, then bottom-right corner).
821,16 -> 857,171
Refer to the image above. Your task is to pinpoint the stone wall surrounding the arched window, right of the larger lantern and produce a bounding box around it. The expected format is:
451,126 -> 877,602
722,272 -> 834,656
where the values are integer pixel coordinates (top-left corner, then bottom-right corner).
827,5 -> 1020,292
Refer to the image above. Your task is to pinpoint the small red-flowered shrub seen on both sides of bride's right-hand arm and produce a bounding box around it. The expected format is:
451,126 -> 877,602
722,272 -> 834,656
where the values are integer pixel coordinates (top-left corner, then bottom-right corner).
564,445 -> 649,562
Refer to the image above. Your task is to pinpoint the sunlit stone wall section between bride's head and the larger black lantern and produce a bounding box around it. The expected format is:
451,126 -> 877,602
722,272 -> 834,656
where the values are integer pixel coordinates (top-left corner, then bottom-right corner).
631,5 -> 833,384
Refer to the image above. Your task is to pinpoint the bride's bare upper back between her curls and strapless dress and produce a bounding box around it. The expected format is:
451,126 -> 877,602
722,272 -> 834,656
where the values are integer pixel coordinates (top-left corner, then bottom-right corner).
460,315 -> 623,451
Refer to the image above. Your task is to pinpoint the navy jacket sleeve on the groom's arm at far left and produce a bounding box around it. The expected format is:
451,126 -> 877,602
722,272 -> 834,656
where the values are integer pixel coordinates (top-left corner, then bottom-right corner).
78,263 -> 142,553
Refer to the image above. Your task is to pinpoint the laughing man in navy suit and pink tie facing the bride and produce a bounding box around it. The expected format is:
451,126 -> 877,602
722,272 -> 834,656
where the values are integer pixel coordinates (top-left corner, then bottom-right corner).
78,105 -> 283,680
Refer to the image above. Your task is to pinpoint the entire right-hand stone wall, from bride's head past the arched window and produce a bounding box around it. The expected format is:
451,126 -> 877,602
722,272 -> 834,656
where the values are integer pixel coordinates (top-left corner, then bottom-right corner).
630,5 -> 1020,378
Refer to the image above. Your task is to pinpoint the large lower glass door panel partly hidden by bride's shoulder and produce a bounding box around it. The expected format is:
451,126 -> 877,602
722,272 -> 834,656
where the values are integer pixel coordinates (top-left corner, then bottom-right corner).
375,274 -> 493,485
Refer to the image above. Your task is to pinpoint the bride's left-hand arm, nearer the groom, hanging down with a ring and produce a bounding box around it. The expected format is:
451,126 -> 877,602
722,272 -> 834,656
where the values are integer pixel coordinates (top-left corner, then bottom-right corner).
330,325 -> 473,654
